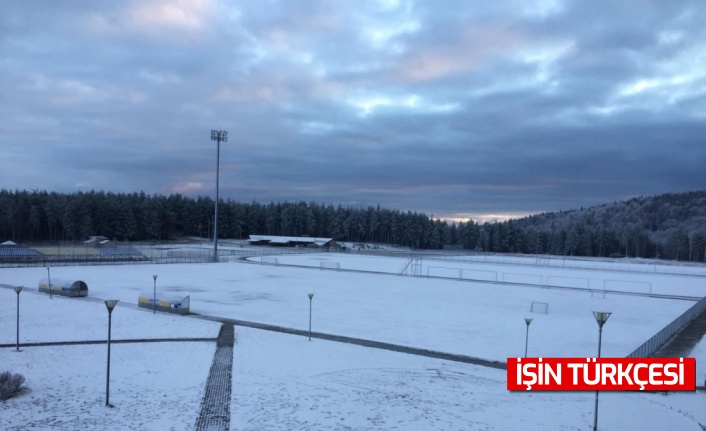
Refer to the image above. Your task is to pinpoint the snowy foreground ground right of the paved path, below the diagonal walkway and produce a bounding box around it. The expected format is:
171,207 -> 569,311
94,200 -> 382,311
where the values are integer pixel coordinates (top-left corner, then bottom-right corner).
231,328 -> 706,431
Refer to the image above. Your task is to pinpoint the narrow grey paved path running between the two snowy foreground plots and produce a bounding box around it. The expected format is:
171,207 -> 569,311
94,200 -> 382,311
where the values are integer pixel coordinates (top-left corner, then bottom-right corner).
195,324 -> 235,431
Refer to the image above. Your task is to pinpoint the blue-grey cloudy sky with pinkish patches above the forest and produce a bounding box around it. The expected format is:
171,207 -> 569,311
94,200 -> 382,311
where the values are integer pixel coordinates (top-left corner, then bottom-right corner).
0,0 -> 706,221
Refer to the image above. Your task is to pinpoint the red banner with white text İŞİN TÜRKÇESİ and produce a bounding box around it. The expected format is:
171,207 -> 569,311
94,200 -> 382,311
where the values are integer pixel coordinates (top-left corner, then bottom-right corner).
507,358 -> 696,391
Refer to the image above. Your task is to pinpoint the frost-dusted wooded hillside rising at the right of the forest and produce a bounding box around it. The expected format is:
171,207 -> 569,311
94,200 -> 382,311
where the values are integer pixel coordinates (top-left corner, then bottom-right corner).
508,191 -> 706,262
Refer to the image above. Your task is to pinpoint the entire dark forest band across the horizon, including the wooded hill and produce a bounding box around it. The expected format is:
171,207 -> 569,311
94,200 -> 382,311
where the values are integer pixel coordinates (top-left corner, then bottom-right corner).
0,190 -> 706,262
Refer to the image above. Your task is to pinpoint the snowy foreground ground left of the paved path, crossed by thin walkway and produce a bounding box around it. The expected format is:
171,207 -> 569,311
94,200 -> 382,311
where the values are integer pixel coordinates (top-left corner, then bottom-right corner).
0,294 -> 220,431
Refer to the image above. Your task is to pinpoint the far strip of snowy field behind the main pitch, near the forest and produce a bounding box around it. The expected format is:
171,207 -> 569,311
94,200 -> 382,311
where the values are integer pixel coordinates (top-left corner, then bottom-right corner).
250,254 -> 706,296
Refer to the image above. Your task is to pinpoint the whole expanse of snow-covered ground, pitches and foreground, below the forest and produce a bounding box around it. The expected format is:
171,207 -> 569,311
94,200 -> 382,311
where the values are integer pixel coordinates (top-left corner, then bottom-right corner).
0,254 -> 706,431
